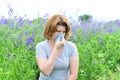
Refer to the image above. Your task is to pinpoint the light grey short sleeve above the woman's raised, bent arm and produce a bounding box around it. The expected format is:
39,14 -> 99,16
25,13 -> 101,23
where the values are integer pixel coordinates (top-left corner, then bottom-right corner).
36,44 -> 47,58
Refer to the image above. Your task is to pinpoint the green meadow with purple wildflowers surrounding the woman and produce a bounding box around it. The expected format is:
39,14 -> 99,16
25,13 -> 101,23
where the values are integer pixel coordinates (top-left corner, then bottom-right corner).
0,8 -> 120,80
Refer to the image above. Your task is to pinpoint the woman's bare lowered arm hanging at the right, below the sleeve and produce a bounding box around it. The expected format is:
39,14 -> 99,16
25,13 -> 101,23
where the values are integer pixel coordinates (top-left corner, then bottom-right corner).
67,56 -> 79,80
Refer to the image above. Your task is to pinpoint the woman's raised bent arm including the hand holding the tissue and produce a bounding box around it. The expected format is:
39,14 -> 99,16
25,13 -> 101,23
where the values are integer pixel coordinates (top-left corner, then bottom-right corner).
37,39 -> 65,76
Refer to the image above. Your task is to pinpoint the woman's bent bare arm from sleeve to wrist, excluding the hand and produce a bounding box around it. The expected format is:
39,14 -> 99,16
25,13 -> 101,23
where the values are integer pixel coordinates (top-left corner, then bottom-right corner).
36,49 -> 57,76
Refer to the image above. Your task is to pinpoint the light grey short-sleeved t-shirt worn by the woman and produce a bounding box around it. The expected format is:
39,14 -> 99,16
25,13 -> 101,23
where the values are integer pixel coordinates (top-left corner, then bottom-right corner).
36,40 -> 78,80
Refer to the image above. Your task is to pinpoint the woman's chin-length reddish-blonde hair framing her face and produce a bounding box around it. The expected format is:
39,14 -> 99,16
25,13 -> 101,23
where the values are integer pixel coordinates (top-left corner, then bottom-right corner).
44,14 -> 71,40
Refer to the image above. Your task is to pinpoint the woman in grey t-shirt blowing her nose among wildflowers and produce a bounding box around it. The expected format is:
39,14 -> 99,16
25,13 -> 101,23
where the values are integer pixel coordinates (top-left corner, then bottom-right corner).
36,14 -> 79,80
